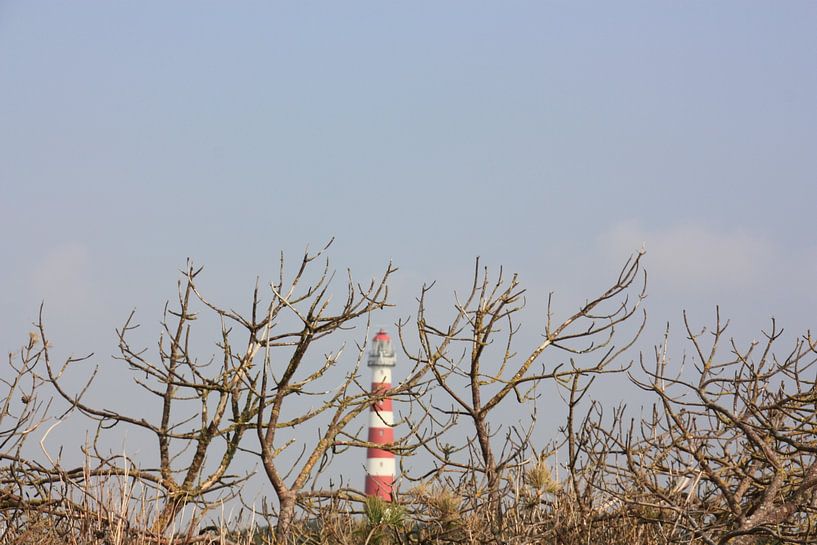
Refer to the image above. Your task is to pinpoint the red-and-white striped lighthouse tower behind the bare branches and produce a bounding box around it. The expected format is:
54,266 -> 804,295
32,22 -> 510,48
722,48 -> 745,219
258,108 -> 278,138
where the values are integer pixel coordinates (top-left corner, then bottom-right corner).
366,329 -> 395,501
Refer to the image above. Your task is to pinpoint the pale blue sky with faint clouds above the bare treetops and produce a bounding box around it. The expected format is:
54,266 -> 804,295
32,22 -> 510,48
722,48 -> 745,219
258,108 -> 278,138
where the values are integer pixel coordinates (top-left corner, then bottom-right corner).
0,0 -> 817,498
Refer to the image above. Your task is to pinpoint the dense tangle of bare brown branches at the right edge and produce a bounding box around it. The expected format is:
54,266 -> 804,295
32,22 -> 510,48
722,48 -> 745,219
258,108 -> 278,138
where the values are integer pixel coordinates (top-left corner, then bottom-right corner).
599,315 -> 817,545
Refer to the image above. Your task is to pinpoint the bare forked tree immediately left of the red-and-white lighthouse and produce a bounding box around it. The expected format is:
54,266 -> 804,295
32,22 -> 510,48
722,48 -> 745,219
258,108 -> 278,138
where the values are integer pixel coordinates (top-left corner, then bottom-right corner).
231,244 -> 426,541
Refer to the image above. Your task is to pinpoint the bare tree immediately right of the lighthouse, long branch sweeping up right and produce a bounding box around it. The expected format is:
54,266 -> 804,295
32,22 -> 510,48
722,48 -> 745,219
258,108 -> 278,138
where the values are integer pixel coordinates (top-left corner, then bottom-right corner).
404,254 -> 644,535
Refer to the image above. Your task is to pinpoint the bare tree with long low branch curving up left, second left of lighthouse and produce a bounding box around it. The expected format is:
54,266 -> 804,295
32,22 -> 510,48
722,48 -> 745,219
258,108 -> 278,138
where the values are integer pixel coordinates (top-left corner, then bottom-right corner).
39,263 -> 258,534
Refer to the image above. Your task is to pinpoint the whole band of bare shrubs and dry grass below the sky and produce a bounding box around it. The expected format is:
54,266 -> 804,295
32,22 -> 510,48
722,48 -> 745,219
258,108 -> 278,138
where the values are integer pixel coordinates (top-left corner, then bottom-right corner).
0,249 -> 817,545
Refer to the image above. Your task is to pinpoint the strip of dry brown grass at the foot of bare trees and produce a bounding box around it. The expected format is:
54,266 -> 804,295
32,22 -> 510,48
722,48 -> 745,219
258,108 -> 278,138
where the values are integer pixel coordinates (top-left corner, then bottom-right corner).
0,465 -> 676,545
